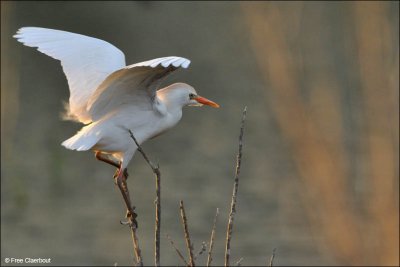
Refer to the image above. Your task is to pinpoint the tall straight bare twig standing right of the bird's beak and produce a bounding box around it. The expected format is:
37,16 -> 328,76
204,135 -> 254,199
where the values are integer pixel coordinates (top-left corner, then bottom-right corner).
225,107 -> 247,266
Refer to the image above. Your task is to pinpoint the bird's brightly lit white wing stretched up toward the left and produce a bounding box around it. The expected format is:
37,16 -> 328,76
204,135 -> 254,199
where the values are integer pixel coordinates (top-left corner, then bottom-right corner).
14,27 -> 126,123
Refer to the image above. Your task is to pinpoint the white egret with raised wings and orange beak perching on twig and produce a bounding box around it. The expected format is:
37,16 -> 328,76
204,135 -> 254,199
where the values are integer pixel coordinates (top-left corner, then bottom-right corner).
13,27 -> 219,182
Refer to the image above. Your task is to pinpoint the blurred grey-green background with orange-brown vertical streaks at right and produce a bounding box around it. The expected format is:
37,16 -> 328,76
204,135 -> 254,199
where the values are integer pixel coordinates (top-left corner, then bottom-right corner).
1,1 -> 399,266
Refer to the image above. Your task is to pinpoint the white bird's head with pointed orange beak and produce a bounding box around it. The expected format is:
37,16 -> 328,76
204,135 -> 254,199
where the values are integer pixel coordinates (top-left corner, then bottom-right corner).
160,83 -> 219,108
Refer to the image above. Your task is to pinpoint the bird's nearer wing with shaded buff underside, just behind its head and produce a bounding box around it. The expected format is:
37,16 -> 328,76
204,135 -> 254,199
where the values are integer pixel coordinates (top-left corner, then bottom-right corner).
87,57 -> 190,120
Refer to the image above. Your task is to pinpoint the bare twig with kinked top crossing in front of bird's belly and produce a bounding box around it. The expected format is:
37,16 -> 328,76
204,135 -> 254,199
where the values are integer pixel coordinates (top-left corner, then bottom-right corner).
129,130 -> 161,266
